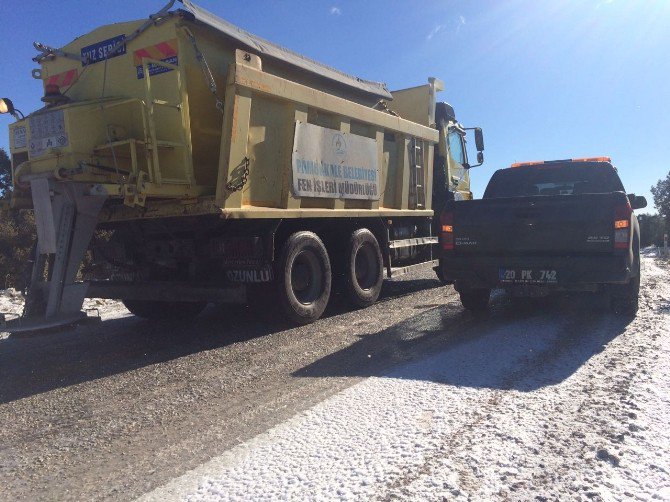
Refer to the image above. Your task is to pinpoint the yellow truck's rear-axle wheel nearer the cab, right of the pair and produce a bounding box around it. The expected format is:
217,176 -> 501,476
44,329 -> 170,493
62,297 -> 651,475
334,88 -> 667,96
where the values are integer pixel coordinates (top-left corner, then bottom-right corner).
345,228 -> 384,307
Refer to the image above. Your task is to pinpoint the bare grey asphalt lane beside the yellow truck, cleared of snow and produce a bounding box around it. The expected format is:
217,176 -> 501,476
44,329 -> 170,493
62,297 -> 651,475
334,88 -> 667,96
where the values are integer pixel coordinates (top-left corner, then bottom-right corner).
0,271 -> 476,500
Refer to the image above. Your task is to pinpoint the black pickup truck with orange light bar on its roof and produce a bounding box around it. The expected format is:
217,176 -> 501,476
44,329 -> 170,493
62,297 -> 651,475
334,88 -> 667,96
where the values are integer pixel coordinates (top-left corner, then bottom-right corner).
440,157 -> 647,314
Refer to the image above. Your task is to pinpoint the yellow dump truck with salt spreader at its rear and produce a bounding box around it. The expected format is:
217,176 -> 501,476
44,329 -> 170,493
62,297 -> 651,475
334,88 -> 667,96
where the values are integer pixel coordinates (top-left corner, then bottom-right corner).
0,0 -> 483,331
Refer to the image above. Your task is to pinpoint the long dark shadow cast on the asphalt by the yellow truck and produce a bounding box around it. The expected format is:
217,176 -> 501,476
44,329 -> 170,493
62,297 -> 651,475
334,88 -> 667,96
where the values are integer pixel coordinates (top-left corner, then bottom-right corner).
0,279 -> 440,403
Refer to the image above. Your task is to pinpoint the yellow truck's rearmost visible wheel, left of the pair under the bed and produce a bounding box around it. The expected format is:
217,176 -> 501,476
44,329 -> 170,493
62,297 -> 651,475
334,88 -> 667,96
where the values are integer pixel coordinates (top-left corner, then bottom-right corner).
277,231 -> 332,325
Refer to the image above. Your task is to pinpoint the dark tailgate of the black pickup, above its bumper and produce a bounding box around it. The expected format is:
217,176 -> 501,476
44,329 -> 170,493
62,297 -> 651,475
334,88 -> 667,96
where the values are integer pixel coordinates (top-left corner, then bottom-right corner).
451,193 -> 619,255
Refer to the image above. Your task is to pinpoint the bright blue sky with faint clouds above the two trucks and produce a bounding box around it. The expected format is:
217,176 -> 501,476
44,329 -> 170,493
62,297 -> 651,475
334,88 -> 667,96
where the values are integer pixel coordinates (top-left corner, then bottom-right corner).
0,0 -> 670,211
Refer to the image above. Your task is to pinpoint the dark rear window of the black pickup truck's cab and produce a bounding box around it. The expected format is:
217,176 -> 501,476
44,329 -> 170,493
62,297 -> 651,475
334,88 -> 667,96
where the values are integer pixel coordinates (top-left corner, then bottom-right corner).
484,164 -> 624,199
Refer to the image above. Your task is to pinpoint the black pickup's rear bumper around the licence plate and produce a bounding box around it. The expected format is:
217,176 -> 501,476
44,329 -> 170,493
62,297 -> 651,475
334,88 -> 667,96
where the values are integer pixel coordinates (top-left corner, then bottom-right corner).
440,254 -> 634,290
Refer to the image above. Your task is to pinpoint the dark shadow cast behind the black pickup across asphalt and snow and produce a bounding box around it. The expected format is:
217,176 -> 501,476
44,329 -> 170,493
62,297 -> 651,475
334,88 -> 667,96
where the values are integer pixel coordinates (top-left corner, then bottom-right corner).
294,294 -> 631,391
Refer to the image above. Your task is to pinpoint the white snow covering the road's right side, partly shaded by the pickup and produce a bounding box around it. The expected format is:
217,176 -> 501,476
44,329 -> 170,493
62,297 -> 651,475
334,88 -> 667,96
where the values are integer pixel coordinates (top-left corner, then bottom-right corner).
144,253 -> 670,501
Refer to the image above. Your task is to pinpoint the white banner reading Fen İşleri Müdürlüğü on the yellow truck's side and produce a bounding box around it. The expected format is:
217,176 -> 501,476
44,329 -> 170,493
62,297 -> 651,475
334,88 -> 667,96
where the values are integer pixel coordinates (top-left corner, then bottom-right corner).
293,122 -> 379,200
